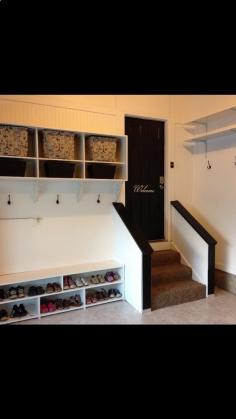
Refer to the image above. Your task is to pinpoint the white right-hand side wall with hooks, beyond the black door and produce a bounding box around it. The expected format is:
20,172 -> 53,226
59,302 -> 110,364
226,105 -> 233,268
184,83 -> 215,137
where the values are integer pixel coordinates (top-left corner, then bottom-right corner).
172,95 -> 236,274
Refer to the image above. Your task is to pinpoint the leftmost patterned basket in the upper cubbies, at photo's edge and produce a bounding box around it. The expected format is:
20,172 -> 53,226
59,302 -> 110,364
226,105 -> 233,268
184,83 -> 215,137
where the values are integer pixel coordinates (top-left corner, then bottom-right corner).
0,126 -> 28,157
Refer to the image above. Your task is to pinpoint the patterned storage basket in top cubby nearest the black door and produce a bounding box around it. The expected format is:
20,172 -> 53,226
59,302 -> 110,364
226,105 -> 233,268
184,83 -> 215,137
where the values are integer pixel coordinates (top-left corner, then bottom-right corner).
87,136 -> 117,161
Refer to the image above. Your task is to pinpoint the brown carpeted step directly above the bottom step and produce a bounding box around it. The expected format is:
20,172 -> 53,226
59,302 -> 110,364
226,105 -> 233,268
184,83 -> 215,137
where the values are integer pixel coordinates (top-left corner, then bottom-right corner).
152,263 -> 192,286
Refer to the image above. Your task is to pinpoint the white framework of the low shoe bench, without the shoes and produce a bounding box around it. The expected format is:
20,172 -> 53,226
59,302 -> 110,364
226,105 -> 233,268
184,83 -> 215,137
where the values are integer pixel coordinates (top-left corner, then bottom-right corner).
0,260 -> 125,324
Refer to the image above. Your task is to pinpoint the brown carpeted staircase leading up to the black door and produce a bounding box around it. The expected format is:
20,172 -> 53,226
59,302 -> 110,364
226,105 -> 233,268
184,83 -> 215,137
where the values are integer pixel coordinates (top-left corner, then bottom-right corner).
152,250 -> 206,310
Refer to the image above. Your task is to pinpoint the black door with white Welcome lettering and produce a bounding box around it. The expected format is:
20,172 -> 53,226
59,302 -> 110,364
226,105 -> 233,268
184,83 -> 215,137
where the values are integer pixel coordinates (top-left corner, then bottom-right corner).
125,117 -> 164,240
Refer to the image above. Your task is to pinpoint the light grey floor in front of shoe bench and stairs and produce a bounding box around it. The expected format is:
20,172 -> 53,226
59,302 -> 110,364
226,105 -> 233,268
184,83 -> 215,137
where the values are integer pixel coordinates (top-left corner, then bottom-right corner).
18,288 -> 236,325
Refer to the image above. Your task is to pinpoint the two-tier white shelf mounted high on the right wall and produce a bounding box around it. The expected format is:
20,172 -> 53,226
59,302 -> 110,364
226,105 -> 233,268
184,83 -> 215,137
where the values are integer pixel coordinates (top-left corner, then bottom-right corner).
185,107 -> 236,143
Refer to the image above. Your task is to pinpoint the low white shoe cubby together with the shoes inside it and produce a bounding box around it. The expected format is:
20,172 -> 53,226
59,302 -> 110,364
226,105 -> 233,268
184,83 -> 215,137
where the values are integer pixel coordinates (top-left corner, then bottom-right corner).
0,261 -> 125,324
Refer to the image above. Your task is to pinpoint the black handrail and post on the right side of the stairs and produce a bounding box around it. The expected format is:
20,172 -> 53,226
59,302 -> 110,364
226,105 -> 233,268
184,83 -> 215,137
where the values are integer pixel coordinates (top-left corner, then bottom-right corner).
171,201 -> 217,294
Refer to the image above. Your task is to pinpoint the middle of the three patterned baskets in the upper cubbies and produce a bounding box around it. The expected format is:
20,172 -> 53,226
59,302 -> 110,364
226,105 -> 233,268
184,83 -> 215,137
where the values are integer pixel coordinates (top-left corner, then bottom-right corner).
43,131 -> 75,160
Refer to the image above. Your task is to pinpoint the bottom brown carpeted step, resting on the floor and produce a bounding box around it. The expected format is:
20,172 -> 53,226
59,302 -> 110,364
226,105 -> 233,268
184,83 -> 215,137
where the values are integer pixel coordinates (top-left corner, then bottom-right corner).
152,279 -> 206,310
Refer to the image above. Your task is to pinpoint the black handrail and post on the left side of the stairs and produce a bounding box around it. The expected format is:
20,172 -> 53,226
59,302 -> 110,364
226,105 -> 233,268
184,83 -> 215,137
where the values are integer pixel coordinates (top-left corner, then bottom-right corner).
113,202 -> 153,310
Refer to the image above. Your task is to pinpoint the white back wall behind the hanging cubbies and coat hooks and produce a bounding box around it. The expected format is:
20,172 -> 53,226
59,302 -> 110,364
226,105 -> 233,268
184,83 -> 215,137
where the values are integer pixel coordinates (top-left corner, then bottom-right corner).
0,95 -> 170,274
